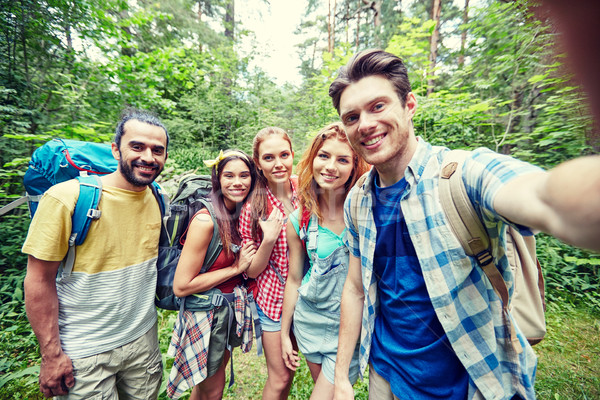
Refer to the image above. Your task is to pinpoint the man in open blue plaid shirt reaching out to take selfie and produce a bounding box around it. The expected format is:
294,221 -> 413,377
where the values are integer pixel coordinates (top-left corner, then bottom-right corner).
329,50 -> 600,400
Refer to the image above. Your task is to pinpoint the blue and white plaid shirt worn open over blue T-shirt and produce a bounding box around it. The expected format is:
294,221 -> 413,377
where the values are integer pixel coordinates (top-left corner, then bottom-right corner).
344,138 -> 540,400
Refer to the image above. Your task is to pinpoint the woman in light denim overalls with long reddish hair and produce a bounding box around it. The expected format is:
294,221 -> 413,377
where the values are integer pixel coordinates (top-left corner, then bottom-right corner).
281,123 -> 368,399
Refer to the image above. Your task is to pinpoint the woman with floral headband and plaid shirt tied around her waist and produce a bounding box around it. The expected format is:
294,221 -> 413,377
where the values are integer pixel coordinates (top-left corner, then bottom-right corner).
167,150 -> 256,399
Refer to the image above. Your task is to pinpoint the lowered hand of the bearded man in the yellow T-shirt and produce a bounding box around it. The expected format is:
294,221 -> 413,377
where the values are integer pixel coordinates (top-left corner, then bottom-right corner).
39,351 -> 75,397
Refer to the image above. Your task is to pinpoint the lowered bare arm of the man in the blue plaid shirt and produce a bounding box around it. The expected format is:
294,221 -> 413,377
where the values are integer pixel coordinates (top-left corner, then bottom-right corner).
334,255 -> 365,400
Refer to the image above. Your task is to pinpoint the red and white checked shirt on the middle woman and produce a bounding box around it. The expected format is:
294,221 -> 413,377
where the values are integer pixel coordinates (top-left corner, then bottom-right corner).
239,184 -> 298,321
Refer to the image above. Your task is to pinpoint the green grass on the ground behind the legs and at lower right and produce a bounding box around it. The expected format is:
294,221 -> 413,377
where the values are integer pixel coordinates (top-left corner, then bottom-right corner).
154,305 -> 600,400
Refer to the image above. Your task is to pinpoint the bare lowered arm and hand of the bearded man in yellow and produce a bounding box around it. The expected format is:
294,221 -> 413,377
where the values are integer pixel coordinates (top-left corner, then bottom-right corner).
24,255 -> 75,397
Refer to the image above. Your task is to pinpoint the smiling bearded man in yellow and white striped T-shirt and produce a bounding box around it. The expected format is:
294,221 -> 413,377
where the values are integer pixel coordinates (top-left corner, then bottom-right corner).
23,110 -> 169,399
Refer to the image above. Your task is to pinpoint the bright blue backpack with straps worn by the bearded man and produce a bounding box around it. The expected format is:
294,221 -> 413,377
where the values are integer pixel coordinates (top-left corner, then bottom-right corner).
23,139 -> 168,277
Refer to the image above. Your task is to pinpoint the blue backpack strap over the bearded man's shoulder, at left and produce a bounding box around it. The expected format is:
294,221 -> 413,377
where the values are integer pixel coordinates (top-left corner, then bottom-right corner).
62,174 -> 102,278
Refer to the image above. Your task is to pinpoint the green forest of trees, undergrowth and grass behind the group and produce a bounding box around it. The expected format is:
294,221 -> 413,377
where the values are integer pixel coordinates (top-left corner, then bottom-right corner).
0,0 -> 600,399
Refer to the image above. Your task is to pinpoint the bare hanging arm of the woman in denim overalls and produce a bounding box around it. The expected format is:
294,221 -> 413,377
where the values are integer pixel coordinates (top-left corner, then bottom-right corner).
281,220 -> 305,371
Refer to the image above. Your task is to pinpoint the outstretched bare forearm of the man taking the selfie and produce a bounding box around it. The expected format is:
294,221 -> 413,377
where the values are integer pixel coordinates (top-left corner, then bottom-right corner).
494,156 -> 600,251
